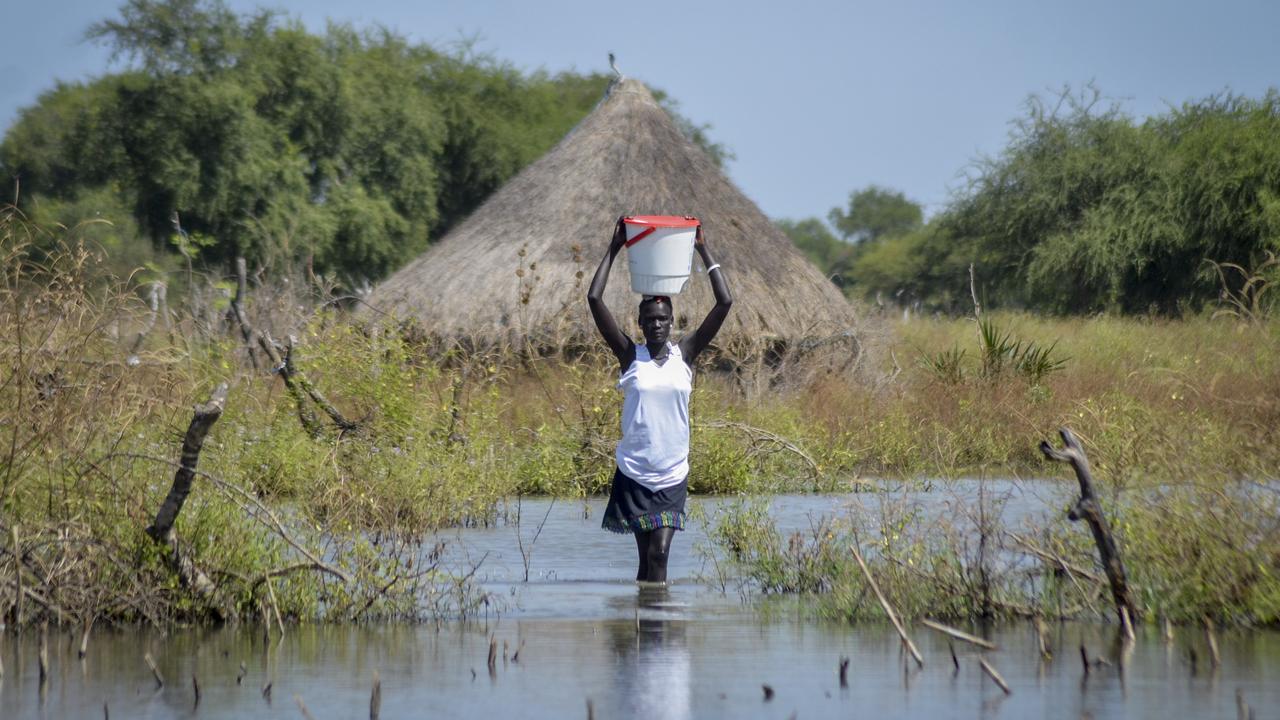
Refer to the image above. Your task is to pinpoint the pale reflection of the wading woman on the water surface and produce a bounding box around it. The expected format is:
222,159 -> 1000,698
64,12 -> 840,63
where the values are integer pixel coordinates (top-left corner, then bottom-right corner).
607,583 -> 692,719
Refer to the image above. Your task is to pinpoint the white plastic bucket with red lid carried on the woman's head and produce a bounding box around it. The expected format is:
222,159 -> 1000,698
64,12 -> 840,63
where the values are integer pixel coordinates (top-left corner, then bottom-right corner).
622,215 -> 700,295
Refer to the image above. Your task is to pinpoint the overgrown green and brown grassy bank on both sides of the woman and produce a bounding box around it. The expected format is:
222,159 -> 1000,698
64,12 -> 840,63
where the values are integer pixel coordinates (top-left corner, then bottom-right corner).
0,206 -> 1280,624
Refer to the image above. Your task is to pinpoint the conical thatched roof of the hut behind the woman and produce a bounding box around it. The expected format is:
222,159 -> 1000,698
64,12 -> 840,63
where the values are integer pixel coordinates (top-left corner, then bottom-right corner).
369,79 -> 855,343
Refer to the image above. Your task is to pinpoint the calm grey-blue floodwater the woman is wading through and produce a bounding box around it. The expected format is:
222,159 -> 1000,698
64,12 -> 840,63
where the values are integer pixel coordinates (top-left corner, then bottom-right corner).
0,483 -> 1280,719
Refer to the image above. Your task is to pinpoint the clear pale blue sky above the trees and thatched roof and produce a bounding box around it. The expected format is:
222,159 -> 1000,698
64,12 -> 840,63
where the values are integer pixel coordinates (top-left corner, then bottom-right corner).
0,0 -> 1280,218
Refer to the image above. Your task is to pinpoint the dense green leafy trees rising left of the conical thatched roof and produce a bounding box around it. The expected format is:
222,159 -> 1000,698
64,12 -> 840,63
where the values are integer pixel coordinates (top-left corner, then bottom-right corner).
0,0 -> 660,282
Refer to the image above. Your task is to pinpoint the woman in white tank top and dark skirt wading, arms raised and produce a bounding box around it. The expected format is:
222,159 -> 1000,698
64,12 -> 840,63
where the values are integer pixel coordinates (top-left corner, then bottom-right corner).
586,218 -> 733,583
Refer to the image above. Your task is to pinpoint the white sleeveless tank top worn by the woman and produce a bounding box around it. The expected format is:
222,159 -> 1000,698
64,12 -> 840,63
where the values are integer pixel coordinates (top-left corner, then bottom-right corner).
614,343 -> 694,491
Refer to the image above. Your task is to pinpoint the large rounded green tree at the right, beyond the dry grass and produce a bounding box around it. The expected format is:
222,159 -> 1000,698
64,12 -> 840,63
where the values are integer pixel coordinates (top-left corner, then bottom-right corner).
896,82 -> 1280,315
